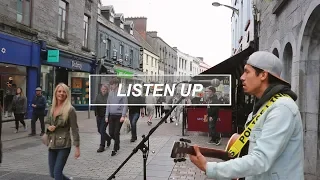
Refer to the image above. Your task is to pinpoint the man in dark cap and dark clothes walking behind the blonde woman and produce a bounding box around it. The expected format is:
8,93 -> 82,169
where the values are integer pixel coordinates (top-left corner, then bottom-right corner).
29,87 -> 47,136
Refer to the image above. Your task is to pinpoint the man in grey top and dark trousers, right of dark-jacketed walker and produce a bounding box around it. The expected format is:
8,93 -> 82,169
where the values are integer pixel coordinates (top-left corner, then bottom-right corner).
106,78 -> 128,156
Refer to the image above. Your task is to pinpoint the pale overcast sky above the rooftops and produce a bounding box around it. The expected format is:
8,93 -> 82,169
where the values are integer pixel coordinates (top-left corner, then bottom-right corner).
101,0 -> 232,66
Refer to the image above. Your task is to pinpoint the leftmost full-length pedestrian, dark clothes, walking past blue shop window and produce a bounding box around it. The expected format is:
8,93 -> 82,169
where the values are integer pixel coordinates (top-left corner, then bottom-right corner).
12,87 -> 27,133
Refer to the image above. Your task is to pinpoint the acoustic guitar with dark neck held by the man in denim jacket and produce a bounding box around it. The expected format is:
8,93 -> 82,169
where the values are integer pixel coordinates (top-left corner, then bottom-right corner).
171,133 -> 240,180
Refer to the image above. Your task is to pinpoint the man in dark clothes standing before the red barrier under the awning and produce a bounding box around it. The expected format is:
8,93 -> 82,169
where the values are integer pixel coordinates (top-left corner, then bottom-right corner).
207,87 -> 221,145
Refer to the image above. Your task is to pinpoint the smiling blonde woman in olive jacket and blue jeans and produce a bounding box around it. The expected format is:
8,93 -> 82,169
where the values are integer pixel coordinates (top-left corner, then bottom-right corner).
46,83 -> 80,180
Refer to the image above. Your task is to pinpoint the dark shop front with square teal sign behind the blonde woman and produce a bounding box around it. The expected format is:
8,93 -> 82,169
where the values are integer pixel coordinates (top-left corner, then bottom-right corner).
40,49 -> 93,110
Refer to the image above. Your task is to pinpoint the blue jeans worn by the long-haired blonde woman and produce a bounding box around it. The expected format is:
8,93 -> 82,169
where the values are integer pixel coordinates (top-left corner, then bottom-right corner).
49,147 -> 71,180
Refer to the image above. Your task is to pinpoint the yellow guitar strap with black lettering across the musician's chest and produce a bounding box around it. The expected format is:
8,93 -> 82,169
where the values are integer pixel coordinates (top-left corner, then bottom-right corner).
228,93 -> 291,157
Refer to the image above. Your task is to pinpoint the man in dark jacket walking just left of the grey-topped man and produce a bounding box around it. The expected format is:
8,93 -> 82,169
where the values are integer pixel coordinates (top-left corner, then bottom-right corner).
94,84 -> 111,153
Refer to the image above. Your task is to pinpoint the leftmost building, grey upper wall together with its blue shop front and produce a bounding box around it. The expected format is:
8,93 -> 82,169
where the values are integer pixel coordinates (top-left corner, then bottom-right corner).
0,0 -> 40,121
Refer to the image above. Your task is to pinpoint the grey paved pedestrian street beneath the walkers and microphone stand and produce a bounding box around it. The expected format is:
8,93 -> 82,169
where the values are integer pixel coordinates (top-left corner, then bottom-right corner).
0,112 -> 226,180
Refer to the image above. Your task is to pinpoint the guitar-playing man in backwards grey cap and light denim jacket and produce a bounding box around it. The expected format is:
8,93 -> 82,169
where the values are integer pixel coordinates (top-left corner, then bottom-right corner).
190,51 -> 304,180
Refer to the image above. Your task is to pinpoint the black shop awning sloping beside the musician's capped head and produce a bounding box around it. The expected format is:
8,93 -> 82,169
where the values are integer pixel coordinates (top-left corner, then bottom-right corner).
193,42 -> 254,79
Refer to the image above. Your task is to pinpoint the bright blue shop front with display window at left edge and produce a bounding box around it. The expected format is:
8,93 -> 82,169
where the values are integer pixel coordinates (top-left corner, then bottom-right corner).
0,33 -> 40,121
